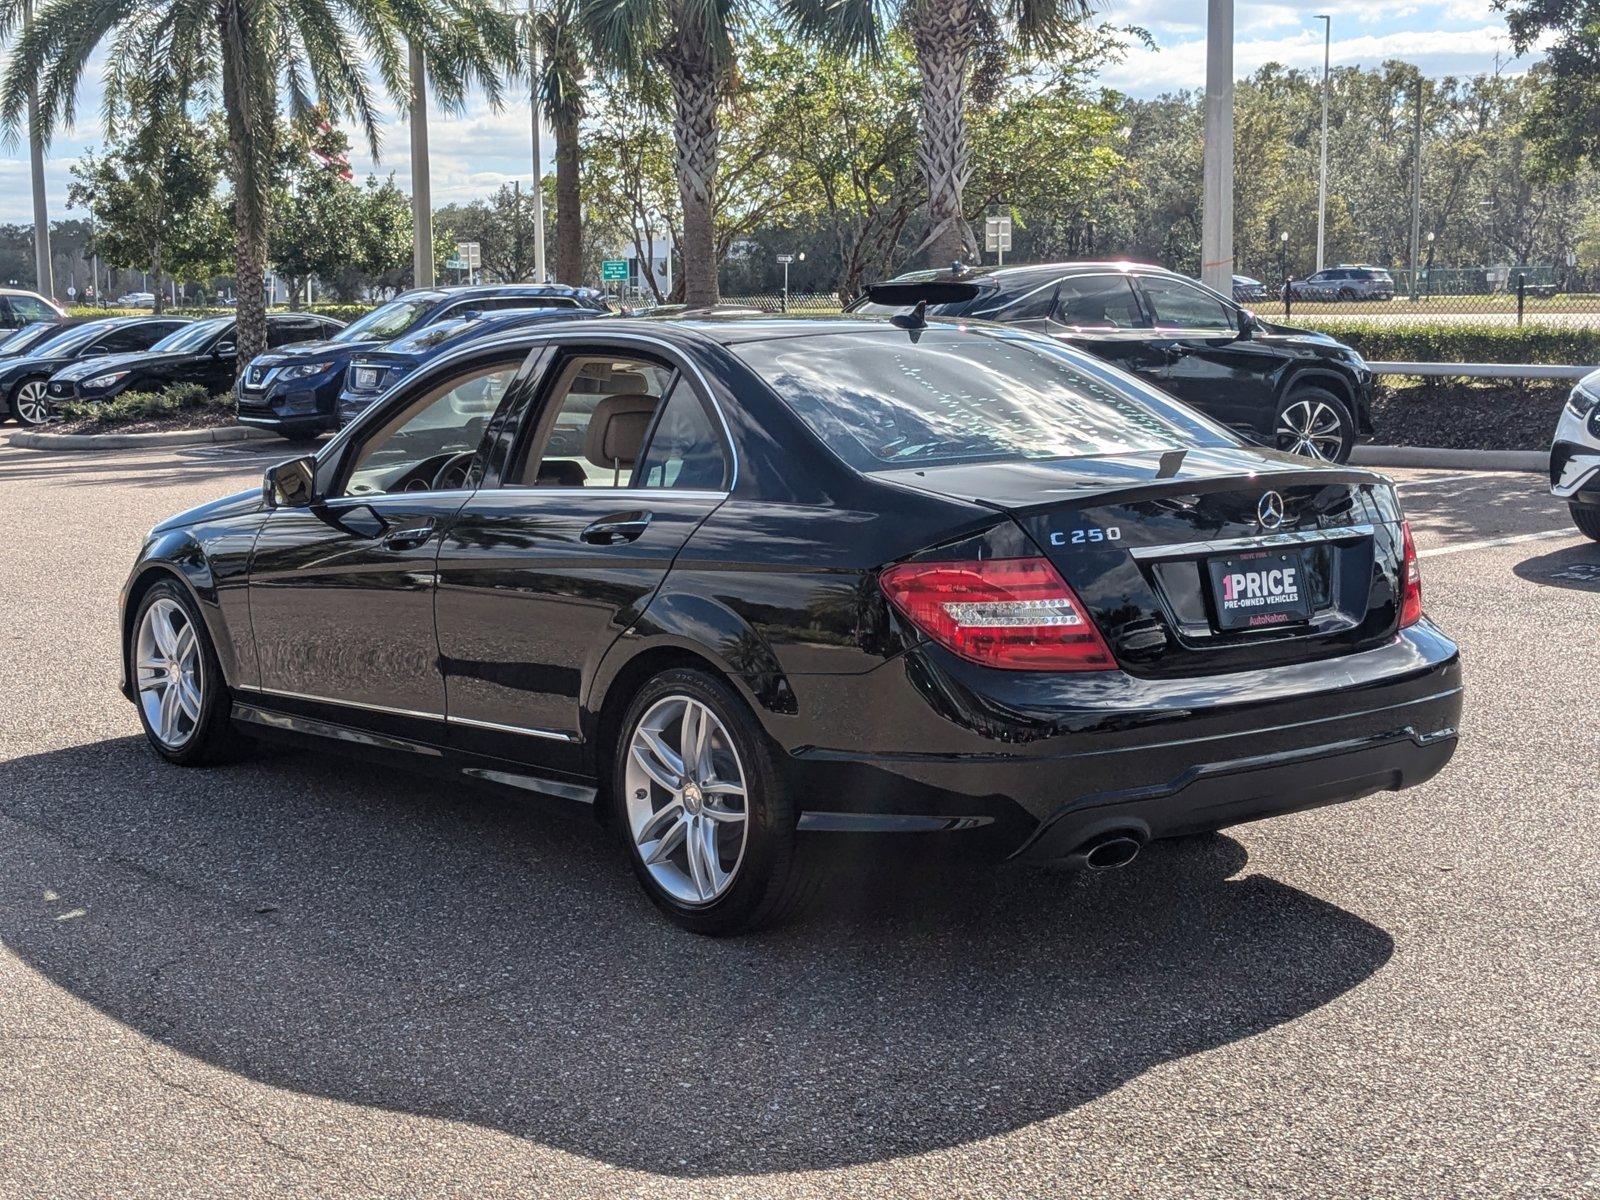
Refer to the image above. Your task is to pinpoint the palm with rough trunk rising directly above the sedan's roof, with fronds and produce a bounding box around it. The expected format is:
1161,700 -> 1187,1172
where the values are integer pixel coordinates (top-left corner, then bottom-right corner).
579,0 -> 742,309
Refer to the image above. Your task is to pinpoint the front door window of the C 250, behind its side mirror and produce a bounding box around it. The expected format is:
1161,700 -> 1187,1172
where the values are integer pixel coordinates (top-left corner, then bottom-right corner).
339,360 -> 522,496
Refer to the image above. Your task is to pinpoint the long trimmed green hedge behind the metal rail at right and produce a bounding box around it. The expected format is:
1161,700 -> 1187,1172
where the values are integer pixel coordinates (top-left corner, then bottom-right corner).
1290,317 -> 1600,366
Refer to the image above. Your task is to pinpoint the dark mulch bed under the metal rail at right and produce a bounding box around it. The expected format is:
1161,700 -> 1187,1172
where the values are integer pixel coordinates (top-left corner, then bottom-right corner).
1373,379 -> 1571,450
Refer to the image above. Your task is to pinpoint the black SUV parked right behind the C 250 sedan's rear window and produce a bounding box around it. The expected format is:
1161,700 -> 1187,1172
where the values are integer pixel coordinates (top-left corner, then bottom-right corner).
848,262 -> 1373,462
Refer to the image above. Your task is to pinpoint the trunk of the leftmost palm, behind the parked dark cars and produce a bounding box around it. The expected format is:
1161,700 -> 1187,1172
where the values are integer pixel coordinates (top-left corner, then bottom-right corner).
218,0 -> 274,371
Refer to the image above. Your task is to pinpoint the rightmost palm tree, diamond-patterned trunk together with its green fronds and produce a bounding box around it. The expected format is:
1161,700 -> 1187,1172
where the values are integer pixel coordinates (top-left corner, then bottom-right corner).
782,0 -> 1091,266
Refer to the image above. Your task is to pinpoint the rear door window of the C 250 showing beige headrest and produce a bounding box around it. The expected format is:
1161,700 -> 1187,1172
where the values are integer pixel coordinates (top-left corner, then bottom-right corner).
507,354 -> 677,488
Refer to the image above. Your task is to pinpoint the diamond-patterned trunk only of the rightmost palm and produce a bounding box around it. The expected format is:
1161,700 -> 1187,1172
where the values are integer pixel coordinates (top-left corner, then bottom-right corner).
910,0 -> 978,267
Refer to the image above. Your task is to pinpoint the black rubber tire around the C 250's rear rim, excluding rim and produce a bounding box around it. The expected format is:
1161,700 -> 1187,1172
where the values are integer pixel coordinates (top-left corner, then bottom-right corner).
608,667 -> 819,936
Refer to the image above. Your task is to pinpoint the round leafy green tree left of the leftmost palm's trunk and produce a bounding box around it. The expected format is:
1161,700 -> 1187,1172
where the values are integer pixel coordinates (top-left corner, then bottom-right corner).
67,109 -> 227,312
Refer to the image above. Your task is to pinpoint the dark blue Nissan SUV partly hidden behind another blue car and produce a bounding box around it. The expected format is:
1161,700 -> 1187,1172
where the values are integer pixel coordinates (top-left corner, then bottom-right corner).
234,283 -> 608,442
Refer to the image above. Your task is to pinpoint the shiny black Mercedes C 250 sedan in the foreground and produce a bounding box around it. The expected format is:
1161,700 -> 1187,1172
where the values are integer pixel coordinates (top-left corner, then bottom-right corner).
122,312 -> 1461,933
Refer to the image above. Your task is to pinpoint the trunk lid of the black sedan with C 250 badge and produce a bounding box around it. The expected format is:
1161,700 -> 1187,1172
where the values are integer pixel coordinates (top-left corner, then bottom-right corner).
883,448 -> 1403,675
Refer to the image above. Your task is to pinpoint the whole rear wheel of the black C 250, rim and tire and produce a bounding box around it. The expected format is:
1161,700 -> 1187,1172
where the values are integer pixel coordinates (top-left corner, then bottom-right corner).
611,669 -> 816,936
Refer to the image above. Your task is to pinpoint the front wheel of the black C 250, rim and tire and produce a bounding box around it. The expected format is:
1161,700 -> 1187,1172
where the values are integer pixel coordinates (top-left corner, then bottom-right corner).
126,579 -> 242,766
